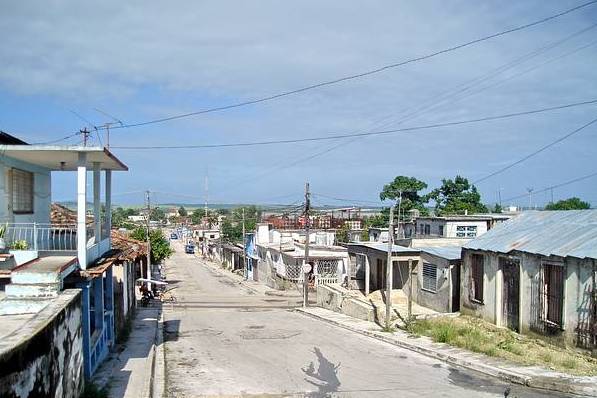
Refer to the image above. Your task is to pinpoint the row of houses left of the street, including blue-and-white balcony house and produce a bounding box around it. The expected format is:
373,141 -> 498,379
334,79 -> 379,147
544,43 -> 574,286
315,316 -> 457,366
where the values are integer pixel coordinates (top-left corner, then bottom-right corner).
0,133 -> 148,397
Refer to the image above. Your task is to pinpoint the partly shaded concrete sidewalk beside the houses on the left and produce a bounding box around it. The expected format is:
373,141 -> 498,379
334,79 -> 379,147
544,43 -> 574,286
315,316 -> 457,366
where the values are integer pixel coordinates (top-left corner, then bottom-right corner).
93,306 -> 161,398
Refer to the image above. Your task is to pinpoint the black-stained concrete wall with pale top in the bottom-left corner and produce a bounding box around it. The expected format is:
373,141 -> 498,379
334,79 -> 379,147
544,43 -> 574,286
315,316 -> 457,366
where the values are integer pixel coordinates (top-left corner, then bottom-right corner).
0,290 -> 83,398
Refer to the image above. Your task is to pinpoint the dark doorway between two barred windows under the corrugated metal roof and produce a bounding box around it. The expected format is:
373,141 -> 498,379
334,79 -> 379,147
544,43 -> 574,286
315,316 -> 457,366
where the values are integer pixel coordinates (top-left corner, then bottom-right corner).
499,258 -> 520,332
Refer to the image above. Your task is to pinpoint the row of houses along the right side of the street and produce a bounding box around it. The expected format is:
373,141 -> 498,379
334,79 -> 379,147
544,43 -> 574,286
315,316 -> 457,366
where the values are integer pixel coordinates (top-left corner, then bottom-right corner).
212,210 -> 597,349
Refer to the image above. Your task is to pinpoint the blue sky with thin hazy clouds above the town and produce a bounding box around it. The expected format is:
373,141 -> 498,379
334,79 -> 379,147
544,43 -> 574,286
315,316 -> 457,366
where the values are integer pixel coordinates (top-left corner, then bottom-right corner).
0,0 -> 597,206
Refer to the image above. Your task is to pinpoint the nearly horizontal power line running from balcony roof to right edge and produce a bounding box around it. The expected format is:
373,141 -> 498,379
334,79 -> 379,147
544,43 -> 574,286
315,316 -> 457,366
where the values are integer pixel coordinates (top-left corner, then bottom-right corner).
112,98 -> 597,150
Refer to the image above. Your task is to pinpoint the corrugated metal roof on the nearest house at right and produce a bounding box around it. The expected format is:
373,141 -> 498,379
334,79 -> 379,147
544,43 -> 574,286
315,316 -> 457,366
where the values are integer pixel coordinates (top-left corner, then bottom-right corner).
463,210 -> 597,259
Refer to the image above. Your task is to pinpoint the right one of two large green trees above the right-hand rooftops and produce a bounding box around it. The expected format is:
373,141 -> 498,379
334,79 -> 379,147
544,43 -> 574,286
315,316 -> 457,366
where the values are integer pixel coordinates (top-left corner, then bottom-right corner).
428,176 -> 487,215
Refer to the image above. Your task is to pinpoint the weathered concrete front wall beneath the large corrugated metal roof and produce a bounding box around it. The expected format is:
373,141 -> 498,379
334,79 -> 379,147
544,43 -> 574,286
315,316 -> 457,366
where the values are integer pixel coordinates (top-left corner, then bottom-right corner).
461,249 -> 595,345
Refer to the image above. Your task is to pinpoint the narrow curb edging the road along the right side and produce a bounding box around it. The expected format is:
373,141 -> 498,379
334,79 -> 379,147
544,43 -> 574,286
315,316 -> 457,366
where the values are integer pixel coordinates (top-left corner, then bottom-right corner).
294,308 -> 597,397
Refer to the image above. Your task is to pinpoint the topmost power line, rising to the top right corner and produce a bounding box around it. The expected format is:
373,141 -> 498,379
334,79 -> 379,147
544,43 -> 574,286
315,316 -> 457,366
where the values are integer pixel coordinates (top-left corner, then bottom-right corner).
47,0 -> 597,138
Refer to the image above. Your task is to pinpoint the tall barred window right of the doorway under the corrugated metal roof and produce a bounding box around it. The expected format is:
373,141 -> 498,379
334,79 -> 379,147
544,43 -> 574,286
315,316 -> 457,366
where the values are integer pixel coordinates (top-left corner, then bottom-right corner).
542,264 -> 564,327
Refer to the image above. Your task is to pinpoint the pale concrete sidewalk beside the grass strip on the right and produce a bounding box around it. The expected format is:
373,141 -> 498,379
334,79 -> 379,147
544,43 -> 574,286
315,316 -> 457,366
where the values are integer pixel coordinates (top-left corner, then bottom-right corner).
296,307 -> 597,397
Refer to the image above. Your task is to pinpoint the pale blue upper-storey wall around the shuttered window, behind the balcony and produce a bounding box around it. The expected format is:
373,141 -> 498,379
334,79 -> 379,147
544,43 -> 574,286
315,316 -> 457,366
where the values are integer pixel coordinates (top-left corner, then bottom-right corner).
0,157 -> 52,224
